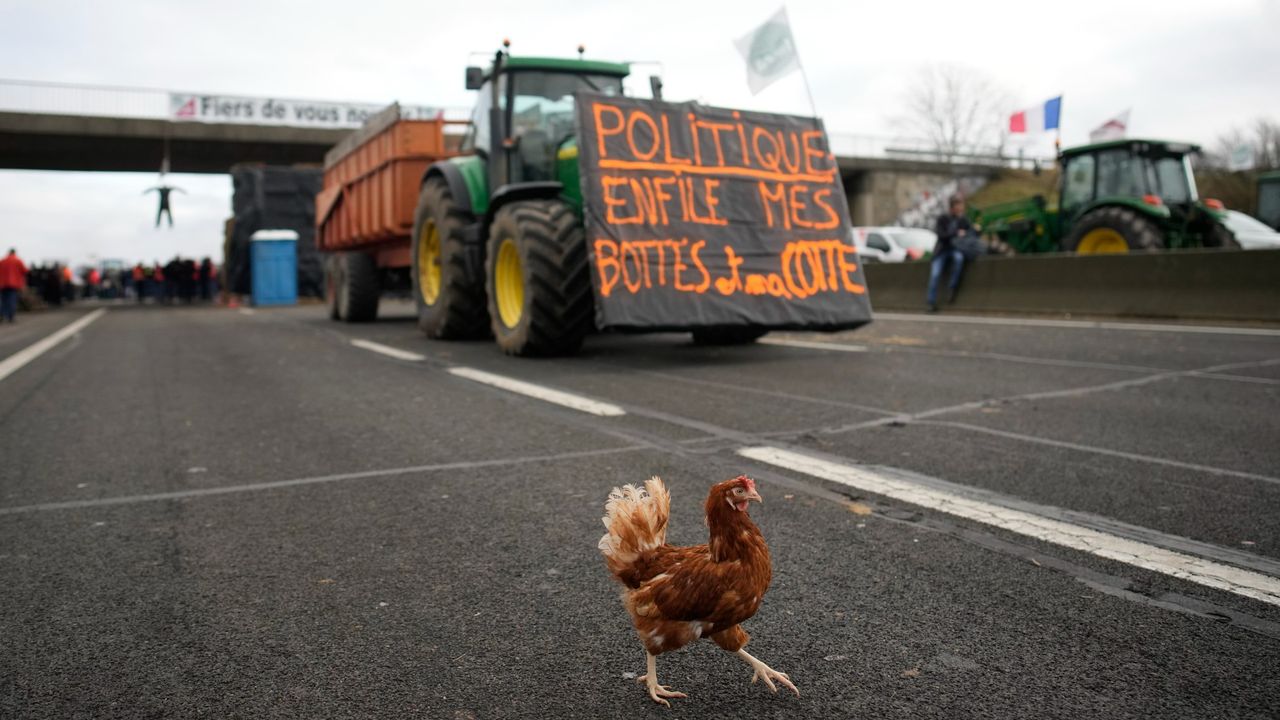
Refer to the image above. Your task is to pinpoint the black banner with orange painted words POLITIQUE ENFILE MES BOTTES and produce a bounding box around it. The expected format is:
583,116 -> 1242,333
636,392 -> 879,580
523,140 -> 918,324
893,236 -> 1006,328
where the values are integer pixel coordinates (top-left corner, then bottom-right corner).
577,94 -> 872,329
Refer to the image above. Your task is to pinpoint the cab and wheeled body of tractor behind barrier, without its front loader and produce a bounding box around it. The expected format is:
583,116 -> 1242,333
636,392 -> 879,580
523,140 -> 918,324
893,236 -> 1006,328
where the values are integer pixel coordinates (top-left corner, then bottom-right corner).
1057,140 -> 1231,254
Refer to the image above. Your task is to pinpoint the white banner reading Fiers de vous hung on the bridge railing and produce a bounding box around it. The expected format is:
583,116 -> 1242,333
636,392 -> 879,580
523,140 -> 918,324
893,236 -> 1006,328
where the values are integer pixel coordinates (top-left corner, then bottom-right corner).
169,92 -> 444,128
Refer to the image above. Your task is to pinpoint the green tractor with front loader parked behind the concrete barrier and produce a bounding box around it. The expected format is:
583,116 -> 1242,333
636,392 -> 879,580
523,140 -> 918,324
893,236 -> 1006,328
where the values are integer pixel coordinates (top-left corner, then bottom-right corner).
974,140 -> 1239,255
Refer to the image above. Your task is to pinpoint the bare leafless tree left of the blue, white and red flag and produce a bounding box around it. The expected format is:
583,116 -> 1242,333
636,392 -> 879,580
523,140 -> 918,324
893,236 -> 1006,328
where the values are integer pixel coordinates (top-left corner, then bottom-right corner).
904,64 -> 1010,159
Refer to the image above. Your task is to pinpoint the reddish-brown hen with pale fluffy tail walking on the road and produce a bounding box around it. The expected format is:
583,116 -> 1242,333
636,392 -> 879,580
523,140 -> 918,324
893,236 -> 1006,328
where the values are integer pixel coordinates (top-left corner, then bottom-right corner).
599,475 -> 800,707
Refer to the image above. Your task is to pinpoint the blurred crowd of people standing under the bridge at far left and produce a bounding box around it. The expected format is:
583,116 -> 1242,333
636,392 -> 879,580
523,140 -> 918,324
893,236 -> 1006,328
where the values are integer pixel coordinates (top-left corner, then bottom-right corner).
0,249 -> 220,322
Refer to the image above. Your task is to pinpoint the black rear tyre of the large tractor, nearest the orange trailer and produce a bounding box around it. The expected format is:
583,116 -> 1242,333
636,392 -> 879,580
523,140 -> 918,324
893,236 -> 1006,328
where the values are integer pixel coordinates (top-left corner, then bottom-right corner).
410,178 -> 489,340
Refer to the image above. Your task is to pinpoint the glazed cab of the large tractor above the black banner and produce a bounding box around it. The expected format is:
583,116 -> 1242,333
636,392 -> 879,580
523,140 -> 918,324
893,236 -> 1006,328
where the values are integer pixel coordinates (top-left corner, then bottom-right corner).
462,49 -> 630,196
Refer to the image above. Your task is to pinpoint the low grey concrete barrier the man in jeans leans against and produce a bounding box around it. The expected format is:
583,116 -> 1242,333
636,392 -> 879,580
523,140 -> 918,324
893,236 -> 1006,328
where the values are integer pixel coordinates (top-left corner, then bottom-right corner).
865,250 -> 1280,323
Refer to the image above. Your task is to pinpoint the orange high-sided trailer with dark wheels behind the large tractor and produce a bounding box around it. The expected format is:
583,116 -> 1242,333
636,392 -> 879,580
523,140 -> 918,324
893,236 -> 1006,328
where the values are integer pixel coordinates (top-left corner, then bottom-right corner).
316,105 -> 468,319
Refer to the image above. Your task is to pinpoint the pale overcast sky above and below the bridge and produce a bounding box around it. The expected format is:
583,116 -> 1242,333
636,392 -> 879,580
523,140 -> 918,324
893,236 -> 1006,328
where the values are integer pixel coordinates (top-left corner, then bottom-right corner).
0,0 -> 1280,263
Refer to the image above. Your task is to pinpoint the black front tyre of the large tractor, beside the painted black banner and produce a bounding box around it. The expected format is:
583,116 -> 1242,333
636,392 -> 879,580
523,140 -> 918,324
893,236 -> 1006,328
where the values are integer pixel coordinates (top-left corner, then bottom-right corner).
485,200 -> 594,356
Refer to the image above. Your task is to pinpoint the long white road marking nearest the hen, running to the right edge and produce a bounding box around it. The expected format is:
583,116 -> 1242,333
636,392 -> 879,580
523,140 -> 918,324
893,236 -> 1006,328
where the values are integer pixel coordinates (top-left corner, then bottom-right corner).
737,446 -> 1280,606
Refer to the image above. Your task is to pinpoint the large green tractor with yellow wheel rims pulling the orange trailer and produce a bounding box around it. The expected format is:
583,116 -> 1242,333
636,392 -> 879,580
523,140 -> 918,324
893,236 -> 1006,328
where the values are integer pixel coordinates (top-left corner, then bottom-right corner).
411,49 -> 634,355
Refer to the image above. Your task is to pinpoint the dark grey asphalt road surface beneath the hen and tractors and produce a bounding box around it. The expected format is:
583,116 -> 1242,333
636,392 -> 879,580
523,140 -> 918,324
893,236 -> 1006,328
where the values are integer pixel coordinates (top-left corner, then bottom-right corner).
0,299 -> 1280,719
